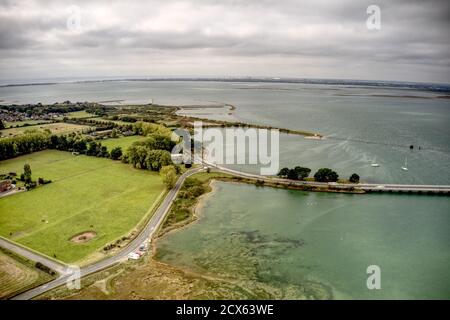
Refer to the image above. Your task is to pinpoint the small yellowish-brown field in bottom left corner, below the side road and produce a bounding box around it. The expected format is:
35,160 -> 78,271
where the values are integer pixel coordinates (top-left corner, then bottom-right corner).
0,249 -> 52,300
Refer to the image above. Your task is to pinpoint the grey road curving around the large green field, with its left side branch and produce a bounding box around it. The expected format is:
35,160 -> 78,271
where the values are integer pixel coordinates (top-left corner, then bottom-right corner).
9,168 -> 203,300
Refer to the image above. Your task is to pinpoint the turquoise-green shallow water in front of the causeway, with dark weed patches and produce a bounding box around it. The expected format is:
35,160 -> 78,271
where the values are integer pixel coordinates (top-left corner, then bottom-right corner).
158,182 -> 450,299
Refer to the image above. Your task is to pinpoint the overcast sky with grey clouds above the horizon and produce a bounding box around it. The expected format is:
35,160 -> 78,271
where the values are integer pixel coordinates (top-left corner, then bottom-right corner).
0,0 -> 450,83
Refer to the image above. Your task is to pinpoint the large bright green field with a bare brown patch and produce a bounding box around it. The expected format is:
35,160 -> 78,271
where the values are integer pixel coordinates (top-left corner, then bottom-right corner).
0,150 -> 164,262
